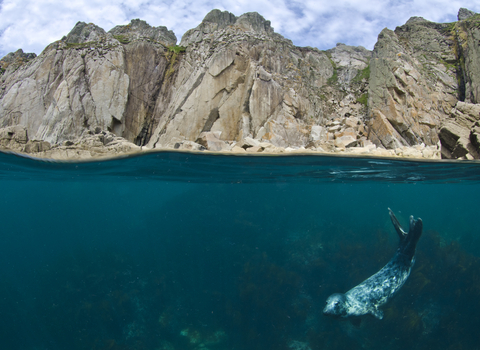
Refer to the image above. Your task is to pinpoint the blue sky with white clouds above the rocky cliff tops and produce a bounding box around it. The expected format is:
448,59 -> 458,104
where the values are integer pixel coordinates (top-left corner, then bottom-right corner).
0,0 -> 480,58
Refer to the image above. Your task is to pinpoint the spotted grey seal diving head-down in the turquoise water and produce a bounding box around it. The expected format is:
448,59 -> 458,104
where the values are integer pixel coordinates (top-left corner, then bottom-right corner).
323,208 -> 423,320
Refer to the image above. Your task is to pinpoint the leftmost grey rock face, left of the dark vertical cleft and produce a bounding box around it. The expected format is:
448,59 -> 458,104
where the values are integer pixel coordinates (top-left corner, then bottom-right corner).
0,21 -> 175,144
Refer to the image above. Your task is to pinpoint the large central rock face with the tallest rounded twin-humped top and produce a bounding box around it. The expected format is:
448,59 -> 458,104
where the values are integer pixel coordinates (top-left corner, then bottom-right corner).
148,10 -> 342,147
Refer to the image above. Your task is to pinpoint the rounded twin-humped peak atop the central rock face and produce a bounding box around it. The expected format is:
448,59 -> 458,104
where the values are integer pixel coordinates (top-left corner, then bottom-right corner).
181,9 -> 274,46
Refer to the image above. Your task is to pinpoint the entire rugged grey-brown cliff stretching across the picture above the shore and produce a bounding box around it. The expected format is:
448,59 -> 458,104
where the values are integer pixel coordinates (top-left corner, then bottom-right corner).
0,9 -> 480,158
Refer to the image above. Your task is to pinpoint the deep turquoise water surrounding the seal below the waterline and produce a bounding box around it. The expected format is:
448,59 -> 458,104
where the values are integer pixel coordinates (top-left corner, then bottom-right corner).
0,152 -> 480,350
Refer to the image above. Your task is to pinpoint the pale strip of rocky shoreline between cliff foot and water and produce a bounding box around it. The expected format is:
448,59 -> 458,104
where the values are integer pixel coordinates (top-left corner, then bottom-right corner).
0,126 -> 462,161
